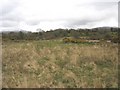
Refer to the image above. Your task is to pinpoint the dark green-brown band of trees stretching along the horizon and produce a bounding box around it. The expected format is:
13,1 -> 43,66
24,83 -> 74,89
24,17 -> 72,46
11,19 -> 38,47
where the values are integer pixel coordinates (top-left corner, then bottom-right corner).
2,27 -> 119,42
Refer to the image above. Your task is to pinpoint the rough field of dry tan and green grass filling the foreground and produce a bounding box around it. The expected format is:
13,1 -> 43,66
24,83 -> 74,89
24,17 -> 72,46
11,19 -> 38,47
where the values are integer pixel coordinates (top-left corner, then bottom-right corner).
2,40 -> 118,88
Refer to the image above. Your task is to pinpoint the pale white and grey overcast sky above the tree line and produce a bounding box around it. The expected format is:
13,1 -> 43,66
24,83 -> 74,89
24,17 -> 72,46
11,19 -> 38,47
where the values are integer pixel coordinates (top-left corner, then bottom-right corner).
0,0 -> 119,31
